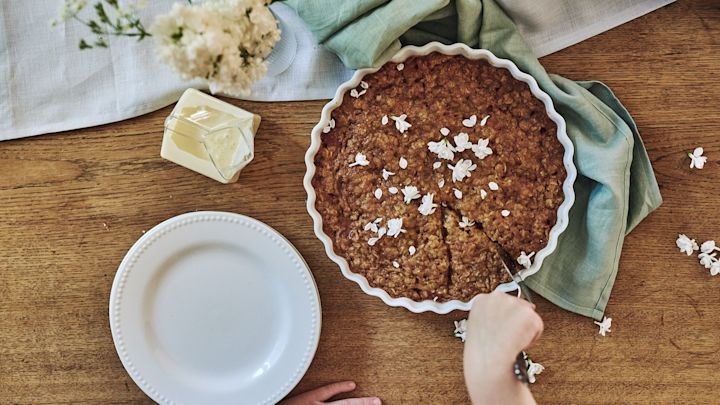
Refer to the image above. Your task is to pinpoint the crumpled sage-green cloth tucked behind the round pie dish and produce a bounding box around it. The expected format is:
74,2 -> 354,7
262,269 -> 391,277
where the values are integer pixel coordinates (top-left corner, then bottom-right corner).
287,0 -> 662,319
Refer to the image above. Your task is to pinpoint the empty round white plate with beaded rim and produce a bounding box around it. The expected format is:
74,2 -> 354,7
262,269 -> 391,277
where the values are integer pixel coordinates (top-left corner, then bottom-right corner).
110,212 -> 321,405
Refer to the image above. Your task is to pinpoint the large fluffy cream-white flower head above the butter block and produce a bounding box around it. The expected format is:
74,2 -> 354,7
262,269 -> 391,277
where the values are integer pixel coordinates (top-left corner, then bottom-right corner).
150,0 -> 280,96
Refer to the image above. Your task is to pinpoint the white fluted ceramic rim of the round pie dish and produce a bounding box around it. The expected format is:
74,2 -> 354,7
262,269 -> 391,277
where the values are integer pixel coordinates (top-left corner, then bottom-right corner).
303,42 -> 577,314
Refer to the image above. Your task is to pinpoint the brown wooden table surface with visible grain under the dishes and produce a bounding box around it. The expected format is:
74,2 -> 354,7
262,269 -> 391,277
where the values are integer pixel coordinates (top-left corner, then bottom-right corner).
0,0 -> 720,404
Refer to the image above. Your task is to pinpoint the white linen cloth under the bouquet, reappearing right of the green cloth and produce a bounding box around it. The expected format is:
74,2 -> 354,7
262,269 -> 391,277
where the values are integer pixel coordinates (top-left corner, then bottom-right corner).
0,0 -> 674,140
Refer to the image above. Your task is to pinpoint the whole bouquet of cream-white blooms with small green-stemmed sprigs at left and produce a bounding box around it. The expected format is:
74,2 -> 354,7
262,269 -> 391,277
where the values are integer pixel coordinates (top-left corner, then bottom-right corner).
53,0 -> 280,96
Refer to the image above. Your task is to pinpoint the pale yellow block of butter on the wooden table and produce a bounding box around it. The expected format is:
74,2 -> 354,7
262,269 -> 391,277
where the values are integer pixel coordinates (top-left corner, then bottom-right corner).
160,89 -> 260,184
